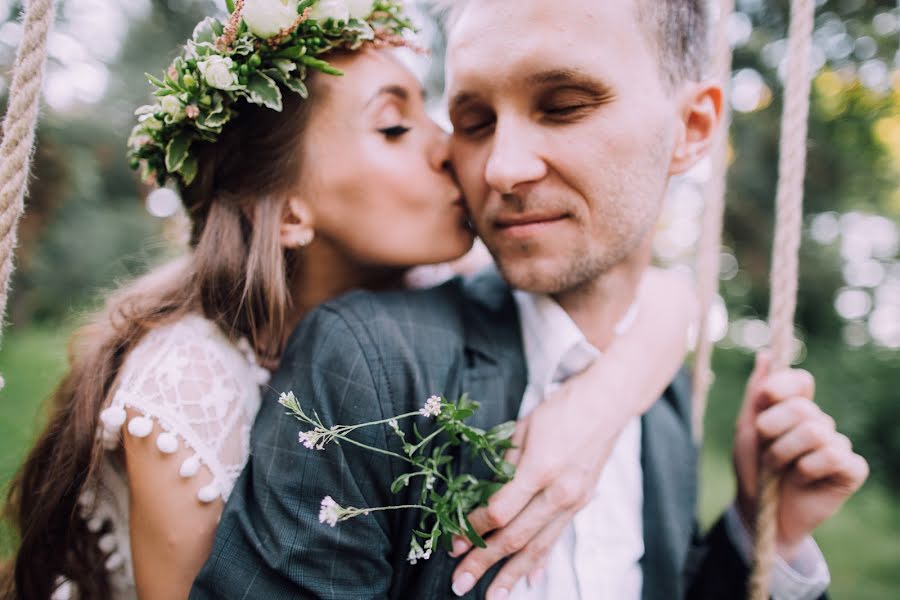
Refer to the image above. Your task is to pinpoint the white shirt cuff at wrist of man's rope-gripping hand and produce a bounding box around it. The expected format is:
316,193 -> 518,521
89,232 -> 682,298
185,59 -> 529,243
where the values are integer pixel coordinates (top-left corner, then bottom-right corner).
725,504 -> 831,600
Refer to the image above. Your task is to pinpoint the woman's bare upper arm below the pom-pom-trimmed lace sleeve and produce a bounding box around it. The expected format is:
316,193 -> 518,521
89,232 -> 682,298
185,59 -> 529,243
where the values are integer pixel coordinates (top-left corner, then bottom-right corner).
123,411 -> 224,600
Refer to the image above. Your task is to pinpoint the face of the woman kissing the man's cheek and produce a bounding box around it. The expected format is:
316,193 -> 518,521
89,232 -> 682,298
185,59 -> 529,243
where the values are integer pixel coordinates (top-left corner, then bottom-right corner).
298,50 -> 473,268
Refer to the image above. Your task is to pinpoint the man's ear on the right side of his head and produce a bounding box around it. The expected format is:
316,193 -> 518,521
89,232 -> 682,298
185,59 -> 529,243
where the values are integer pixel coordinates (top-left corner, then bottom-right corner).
669,81 -> 723,175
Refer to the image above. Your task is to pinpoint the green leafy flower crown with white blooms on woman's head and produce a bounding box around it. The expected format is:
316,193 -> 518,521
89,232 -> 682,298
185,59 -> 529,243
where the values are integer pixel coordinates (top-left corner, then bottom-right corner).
128,0 -> 414,187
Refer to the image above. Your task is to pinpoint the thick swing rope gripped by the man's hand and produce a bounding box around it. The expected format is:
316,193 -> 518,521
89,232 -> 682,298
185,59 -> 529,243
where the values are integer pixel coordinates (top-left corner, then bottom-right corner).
750,0 -> 815,600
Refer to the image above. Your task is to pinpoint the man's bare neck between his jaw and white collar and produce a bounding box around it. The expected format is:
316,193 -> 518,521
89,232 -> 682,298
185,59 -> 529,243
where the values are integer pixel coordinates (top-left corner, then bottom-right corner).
554,244 -> 651,350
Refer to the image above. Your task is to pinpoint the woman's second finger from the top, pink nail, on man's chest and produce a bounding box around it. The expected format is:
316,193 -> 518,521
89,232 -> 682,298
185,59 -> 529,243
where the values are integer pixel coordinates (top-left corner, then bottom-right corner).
453,492 -> 570,596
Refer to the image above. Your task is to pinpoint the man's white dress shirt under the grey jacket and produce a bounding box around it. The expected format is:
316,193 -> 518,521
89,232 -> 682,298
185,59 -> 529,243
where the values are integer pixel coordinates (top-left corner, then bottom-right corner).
510,292 -> 830,600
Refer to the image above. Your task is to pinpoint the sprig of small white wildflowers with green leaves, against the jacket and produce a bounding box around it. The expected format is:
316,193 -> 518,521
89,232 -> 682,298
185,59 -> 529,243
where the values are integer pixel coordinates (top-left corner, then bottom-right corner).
279,392 -> 515,564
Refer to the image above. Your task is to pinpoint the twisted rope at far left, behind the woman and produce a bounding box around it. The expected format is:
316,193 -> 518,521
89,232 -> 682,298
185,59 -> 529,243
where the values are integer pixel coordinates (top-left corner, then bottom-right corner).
0,0 -> 53,389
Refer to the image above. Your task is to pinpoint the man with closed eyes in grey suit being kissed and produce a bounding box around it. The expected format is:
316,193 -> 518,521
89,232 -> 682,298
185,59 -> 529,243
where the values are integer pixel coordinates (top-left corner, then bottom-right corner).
191,0 -> 866,600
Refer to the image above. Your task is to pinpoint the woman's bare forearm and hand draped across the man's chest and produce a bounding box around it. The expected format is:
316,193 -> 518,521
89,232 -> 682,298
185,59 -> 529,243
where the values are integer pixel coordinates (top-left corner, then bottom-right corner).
453,269 -> 697,600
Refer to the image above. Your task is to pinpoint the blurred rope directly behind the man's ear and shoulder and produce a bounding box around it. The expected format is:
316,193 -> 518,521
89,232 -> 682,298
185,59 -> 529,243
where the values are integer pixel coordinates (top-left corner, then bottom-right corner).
692,0 -> 734,444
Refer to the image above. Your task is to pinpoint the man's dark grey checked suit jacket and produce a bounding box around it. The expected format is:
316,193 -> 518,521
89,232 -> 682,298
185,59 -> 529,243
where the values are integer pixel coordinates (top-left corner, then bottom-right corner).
190,272 -> 776,600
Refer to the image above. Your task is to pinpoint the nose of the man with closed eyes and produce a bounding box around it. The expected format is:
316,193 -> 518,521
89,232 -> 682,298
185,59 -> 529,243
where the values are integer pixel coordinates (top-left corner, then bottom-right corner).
484,120 -> 547,194
